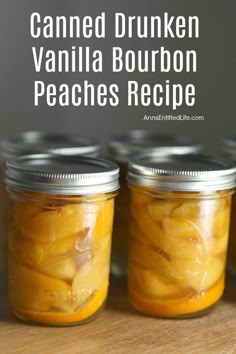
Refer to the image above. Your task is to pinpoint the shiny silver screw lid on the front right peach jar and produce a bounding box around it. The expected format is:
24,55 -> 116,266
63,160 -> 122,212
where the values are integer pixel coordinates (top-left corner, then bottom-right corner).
128,154 -> 236,192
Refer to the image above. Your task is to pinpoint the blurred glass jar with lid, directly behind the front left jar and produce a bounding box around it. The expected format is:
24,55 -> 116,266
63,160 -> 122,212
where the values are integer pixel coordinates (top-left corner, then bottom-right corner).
0,131 -> 101,277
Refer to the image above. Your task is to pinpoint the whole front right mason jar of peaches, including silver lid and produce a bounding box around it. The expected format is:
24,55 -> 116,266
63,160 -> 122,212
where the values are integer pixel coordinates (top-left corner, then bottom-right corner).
128,155 -> 236,318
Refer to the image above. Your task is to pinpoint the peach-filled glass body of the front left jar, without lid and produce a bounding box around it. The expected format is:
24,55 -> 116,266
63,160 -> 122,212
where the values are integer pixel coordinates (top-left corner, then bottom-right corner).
9,188 -> 114,325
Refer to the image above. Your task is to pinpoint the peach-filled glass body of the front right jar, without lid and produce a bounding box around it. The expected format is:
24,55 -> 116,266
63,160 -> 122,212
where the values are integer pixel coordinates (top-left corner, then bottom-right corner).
128,184 -> 233,317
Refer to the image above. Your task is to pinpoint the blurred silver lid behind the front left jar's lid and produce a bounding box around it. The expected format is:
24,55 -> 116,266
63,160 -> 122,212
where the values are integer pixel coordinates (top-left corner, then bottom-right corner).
0,131 -> 101,161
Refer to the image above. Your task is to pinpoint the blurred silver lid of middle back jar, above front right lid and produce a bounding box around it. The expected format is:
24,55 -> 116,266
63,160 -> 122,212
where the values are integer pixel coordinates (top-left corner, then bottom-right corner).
108,130 -> 201,162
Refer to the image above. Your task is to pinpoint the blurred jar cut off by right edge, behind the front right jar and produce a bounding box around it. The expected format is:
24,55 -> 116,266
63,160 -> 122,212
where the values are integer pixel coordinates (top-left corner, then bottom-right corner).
222,136 -> 236,276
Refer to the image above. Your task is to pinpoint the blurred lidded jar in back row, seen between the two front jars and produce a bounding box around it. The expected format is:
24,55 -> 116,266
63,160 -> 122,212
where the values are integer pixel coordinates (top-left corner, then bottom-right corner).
108,130 -> 201,277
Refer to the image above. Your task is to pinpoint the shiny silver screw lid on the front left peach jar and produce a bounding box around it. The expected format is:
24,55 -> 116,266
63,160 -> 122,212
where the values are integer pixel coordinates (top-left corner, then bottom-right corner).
6,154 -> 119,195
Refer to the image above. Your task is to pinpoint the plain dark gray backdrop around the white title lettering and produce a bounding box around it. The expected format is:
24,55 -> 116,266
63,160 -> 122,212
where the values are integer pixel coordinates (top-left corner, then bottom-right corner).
0,0 -> 236,148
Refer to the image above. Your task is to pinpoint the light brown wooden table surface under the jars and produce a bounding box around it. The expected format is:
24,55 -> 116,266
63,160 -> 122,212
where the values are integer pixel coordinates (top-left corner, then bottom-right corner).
0,279 -> 236,354
